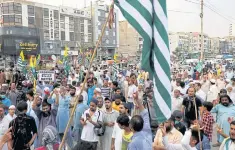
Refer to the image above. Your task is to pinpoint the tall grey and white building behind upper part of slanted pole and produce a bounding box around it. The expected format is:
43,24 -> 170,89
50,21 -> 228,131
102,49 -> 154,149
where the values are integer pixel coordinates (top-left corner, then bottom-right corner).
83,0 -> 119,59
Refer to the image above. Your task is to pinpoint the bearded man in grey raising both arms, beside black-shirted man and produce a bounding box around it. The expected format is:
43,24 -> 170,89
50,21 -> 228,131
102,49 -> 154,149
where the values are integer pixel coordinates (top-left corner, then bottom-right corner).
32,91 -> 59,147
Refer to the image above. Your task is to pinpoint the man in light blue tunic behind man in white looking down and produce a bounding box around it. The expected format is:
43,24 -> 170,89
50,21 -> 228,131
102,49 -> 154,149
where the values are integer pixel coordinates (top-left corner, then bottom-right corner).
73,95 -> 88,142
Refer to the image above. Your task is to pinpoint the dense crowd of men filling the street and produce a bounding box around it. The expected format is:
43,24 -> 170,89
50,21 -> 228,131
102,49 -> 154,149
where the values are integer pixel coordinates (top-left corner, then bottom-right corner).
0,60 -> 235,150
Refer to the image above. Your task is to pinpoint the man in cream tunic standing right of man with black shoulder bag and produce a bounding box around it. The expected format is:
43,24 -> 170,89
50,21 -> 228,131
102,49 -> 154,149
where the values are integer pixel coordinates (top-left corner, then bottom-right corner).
100,98 -> 119,150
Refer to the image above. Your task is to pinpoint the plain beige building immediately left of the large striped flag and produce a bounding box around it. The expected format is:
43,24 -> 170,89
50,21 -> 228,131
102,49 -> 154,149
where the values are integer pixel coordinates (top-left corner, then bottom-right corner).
118,21 -> 143,60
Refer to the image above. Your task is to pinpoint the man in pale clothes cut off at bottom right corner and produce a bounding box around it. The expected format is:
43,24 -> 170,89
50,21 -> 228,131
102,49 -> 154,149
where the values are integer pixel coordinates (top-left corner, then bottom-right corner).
219,121 -> 235,150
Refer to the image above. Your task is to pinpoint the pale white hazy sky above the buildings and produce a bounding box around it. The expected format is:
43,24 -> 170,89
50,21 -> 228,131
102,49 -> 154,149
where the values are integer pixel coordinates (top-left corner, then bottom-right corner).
33,0 -> 235,37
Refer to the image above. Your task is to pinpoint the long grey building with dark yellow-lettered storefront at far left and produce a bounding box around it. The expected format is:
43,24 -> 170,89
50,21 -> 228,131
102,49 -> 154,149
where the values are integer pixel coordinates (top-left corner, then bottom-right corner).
0,0 -> 93,66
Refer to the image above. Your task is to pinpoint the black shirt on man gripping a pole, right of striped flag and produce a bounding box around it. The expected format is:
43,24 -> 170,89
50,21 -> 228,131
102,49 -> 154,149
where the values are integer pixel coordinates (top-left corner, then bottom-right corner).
182,97 -> 202,120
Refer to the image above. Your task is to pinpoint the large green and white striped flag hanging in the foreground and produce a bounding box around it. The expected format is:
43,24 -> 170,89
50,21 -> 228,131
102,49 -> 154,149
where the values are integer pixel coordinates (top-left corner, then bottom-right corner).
114,0 -> 171,123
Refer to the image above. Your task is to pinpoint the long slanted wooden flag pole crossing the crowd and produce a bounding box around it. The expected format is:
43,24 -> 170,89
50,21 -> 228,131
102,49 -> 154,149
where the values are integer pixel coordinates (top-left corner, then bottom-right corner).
59,1 -> 114,150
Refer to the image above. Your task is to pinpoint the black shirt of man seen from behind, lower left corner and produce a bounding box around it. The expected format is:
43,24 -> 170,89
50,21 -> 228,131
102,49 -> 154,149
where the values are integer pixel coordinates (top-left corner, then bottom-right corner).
9,114 -> 37,150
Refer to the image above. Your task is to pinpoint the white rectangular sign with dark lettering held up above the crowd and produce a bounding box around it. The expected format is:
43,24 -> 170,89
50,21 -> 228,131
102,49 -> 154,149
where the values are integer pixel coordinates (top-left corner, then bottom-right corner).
38,70 -> 55,81
